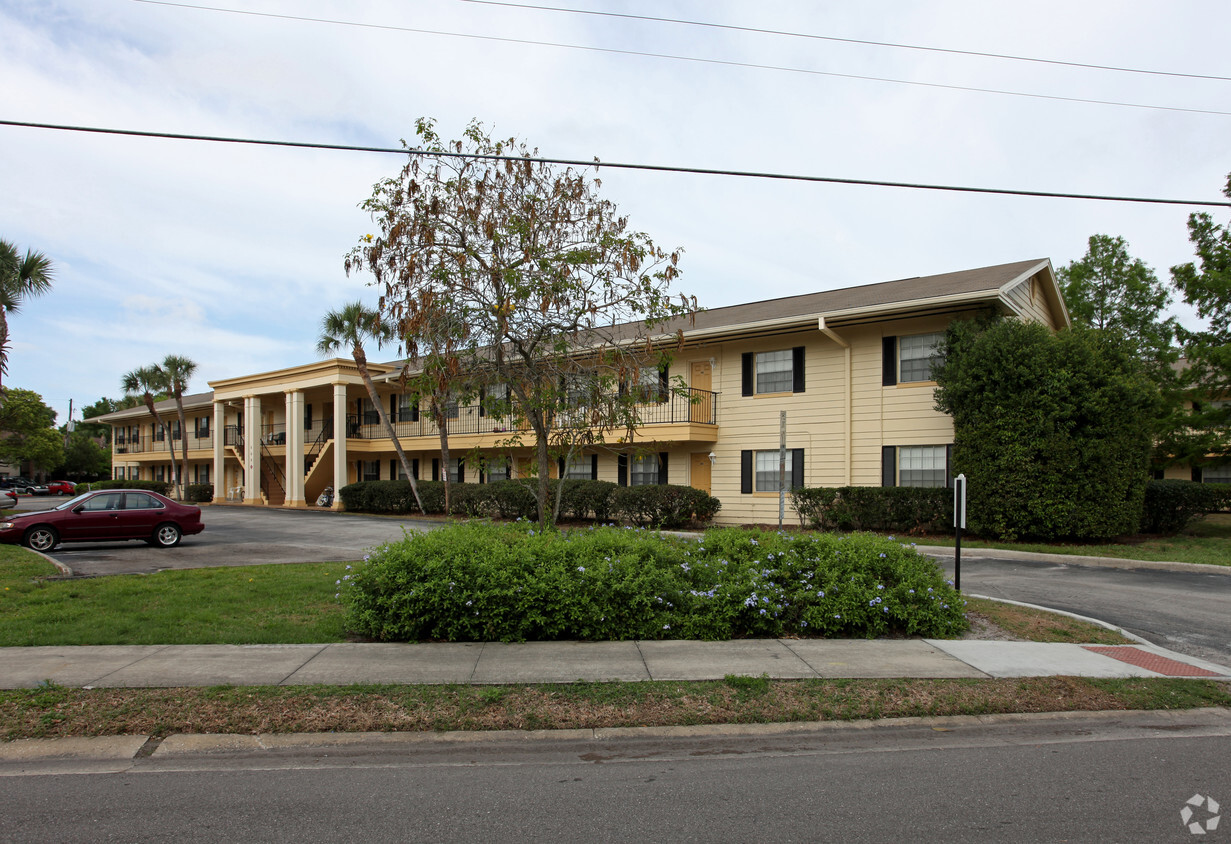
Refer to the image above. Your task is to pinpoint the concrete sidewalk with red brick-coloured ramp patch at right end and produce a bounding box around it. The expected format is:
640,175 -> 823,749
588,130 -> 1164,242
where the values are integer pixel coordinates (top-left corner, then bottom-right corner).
0,639 -> 1231,689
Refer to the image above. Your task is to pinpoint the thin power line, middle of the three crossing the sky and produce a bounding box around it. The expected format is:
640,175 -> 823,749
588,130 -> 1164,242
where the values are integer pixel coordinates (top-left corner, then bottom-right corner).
133,0 -> 1231,117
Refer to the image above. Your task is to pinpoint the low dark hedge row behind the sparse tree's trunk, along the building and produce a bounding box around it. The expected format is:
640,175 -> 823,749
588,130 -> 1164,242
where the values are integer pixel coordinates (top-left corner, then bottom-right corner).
339,480 -> 721,528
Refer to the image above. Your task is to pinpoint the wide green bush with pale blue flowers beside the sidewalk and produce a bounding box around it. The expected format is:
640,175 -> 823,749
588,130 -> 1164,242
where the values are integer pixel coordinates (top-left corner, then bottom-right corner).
339,523 -> 966,642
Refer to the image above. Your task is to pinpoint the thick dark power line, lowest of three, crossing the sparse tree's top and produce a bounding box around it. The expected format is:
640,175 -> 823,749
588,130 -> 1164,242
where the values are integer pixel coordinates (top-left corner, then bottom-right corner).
0,119 -> 1231,208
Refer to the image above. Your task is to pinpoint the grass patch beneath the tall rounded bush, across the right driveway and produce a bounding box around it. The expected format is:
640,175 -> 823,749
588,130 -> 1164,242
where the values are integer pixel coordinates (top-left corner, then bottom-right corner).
918,513 -> 1231,566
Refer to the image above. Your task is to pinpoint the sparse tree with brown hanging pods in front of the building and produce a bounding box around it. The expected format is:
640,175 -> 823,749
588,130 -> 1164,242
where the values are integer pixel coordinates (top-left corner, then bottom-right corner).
346,119 -> 697,527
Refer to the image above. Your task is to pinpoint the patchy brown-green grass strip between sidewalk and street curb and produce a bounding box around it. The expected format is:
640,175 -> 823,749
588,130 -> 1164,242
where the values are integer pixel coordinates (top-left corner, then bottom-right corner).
0,677 -> 1231,741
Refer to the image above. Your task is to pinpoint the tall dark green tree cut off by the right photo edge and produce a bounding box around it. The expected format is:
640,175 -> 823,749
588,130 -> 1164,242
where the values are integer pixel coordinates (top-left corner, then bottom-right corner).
1171,175 -> 1231,459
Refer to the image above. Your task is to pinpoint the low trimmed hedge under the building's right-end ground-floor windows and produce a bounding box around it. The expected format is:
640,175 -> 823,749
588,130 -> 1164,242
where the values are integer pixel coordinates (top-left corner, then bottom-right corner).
790,486 -> 953,533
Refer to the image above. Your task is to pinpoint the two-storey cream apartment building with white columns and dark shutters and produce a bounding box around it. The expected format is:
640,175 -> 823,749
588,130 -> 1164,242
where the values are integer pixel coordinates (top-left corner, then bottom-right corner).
102,258 -> 1069,524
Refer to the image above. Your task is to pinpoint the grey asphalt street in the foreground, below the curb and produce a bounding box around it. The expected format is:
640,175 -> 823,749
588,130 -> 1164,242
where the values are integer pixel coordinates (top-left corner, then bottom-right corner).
0,712 -> 1231,844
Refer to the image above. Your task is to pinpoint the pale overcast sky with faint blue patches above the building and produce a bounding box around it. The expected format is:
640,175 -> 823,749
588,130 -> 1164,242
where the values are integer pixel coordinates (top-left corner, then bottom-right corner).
0,0 -> 1231,423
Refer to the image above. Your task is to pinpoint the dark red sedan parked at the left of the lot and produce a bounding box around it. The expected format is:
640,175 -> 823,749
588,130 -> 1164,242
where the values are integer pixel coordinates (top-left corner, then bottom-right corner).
0,490 -> 206,551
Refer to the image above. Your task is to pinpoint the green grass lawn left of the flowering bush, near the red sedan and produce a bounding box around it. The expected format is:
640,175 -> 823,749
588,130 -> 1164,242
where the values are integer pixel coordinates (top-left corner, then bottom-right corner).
0,545 -> 346,647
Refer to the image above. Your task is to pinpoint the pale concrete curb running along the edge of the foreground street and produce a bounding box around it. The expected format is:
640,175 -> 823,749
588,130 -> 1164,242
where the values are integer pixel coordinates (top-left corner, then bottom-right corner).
0,707 -> 1231,775
